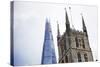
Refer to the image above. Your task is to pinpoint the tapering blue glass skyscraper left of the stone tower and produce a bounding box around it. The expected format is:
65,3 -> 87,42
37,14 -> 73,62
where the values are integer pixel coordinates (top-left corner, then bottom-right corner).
41,19 -> 57,64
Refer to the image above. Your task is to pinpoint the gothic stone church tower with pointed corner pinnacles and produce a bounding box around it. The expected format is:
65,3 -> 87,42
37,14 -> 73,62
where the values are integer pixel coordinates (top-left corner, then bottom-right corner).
57,10 -> 93,63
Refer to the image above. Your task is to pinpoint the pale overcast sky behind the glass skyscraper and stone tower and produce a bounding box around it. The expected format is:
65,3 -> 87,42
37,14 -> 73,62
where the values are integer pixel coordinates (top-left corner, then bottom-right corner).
14,1 -> 97,64
